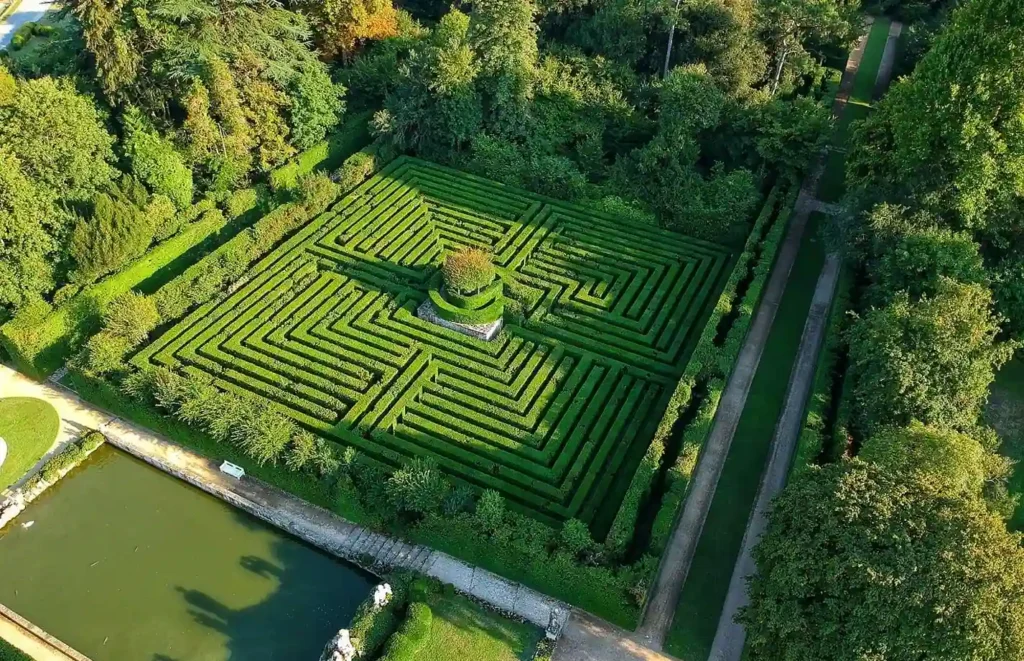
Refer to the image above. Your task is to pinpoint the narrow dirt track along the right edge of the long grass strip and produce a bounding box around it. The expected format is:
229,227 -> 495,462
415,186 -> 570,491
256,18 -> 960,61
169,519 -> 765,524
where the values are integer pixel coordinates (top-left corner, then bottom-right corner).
710,21 -> 902,661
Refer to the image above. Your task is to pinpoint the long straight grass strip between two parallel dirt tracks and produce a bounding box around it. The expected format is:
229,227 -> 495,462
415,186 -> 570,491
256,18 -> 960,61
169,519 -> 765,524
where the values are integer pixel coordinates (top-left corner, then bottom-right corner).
665,15 -> 890,661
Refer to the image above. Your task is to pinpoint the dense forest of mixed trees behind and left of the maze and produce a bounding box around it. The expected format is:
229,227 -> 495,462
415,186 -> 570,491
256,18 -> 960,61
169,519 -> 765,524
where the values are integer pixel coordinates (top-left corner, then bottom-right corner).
0,0 -> 860,315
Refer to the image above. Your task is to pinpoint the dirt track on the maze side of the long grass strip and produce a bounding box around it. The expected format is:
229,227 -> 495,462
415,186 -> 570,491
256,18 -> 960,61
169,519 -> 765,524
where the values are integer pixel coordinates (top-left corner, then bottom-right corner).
637,25 -> 866,650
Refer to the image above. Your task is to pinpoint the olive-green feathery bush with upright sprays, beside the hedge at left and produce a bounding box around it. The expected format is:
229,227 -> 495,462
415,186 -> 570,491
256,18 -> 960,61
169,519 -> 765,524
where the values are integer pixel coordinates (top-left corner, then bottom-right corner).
71,177 -> 155,283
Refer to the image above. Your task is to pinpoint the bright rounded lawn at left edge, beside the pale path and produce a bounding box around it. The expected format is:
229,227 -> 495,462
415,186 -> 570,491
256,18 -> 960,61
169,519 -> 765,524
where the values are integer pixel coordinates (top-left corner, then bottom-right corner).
0,397 -> 60,489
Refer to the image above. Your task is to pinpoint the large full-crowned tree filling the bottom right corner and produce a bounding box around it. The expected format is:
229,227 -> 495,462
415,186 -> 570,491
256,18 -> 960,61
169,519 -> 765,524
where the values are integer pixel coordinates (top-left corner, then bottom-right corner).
740,459 -> 1024,661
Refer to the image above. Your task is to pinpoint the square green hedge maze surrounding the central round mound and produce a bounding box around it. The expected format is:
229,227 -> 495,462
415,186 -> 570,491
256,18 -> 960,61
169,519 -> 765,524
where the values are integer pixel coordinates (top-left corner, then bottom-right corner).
134,158 -> 731,536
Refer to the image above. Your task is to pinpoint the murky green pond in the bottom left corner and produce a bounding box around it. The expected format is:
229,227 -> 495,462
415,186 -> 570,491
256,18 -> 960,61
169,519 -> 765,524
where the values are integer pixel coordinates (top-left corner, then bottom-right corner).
0,446 -> 375,661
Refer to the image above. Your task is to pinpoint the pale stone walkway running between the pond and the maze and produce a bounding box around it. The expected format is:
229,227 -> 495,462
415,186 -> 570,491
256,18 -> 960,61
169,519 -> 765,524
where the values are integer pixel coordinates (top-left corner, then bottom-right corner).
0,365 -> 569,627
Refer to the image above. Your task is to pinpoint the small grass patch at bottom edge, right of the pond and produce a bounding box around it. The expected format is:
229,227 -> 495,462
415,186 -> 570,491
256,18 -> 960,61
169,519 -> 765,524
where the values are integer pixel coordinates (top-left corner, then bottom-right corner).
416,593 -> 543,661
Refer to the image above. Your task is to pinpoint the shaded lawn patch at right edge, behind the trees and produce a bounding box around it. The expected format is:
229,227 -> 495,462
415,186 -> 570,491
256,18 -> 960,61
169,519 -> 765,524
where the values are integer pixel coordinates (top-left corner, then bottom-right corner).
988,357 -> 1024,530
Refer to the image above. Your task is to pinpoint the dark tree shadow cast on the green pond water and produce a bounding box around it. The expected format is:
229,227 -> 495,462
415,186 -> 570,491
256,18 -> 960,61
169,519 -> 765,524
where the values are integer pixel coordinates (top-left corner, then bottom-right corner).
175,513 -> 375,661
